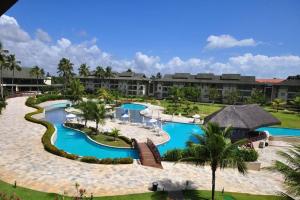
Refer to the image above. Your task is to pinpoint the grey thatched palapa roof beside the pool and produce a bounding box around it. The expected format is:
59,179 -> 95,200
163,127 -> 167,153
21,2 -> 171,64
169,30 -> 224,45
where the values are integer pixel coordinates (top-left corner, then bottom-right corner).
204,104 -> 281,130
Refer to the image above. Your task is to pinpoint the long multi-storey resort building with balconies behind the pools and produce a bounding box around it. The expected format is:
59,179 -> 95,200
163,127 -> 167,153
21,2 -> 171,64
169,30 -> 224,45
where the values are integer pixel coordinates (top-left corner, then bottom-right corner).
80,72 -> 300,102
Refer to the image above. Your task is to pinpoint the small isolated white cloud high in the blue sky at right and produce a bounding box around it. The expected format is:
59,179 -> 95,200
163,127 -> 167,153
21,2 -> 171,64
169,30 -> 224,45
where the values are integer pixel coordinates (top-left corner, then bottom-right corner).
205,35 -> 257,49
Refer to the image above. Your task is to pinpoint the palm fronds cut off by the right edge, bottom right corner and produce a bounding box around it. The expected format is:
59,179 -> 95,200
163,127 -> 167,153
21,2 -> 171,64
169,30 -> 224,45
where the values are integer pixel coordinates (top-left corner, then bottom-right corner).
270,144 -> 300,199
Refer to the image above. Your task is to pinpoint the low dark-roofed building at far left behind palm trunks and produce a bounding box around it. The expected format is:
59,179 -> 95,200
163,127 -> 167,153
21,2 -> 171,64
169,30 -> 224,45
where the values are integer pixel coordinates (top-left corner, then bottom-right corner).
2,67 -> 51,92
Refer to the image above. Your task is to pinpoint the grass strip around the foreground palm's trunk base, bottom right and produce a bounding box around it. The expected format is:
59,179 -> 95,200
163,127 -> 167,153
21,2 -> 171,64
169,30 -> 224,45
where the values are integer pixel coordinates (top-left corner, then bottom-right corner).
184,190 -> 280,200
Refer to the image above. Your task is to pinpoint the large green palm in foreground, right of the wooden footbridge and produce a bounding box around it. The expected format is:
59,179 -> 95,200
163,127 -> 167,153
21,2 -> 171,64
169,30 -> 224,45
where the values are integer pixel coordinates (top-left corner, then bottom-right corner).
179,123 -> 247,200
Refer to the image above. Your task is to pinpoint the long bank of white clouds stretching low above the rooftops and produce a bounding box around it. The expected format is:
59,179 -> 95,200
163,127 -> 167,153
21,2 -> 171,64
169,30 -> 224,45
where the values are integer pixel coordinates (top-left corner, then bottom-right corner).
0,15 -> 300,78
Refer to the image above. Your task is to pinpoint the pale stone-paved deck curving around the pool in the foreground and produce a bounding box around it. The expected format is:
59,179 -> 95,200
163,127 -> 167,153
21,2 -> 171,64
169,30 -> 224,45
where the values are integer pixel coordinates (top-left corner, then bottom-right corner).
0,97 -> 287,196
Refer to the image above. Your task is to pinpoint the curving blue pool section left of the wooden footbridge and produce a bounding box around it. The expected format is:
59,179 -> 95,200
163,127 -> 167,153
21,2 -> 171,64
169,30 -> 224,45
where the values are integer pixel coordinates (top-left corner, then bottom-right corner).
46,108 -> 138,158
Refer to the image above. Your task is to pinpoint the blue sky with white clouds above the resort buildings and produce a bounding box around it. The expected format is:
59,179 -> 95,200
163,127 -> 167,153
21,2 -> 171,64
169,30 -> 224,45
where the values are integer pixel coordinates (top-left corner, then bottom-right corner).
0,0 -> 300,78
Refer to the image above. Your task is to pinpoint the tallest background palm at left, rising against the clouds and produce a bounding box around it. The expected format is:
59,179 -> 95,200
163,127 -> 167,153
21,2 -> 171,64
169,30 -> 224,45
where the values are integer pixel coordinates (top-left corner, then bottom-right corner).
57,58 -> 74,92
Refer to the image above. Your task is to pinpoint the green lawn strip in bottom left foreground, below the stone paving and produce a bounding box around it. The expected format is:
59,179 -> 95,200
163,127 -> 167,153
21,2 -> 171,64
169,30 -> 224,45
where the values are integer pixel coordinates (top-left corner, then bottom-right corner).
0,180 -> 167,200
